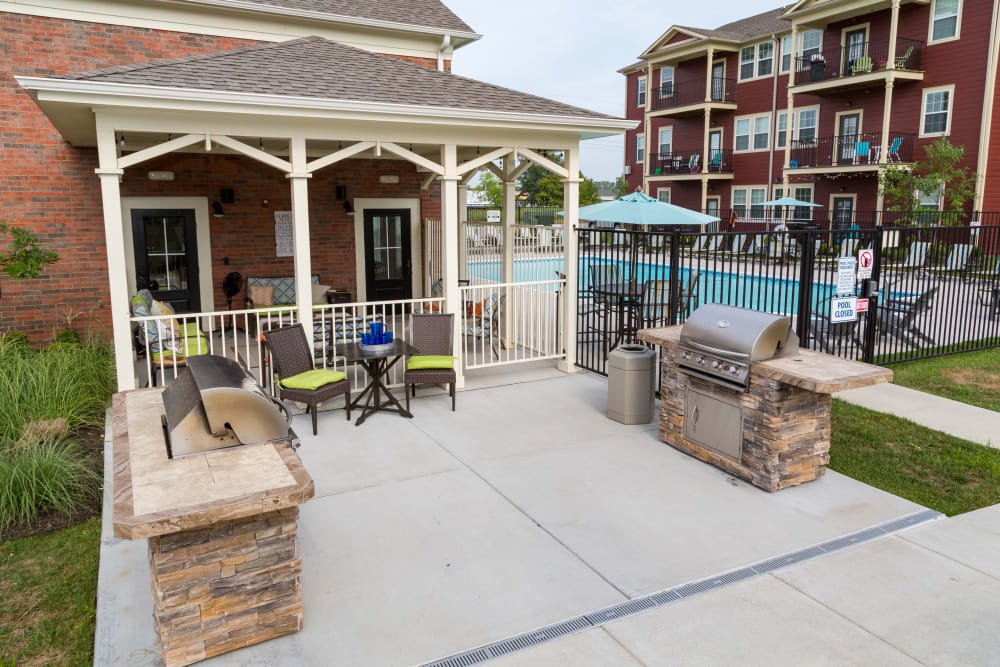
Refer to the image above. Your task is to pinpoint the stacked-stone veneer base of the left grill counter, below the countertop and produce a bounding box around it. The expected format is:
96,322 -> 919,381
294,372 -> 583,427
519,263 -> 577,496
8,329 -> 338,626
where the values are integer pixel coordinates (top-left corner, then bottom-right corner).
149,507 -> 302,666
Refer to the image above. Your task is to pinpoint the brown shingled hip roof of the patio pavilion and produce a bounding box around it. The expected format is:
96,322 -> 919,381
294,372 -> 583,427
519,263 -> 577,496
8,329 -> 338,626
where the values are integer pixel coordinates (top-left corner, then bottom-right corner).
53,37 -> 614,119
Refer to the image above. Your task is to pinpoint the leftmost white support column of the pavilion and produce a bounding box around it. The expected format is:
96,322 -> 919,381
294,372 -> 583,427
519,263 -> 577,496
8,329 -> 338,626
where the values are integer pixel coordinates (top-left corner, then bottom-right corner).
95,116 -> 135,391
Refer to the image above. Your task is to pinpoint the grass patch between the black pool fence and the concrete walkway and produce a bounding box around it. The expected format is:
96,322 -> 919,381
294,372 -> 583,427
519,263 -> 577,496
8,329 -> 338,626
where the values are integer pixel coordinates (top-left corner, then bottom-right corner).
890,348 -> 1000,412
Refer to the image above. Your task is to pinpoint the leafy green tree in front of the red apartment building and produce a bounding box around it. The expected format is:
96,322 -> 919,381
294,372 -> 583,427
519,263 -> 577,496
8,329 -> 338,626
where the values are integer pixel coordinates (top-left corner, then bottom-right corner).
879,137 -> 979,211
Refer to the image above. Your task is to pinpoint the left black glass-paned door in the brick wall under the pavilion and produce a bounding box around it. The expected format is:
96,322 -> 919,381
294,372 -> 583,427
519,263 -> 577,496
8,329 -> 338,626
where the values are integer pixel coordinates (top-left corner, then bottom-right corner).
132,210 -> 201,313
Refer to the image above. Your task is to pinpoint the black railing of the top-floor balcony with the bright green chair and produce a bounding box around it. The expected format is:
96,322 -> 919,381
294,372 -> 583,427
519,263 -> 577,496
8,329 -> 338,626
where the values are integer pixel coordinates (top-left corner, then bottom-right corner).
795,37 -> 924,86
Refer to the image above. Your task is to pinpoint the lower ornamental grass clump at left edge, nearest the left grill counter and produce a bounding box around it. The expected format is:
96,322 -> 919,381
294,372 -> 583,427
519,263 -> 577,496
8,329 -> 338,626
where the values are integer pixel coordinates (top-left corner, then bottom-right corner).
0,435 -> 101,532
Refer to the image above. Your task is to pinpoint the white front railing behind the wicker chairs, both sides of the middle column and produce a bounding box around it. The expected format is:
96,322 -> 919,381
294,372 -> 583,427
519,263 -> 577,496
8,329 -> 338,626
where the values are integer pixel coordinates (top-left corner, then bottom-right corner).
131,297 -> 444,393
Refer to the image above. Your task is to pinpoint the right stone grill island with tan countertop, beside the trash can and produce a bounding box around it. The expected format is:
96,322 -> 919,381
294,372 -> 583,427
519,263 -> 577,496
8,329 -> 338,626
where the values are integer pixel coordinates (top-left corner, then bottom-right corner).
639,326 -> 892,491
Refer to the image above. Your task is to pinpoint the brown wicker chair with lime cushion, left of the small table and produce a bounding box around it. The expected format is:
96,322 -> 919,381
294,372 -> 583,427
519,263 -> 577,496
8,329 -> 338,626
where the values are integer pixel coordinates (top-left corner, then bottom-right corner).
263,324 -> 351,435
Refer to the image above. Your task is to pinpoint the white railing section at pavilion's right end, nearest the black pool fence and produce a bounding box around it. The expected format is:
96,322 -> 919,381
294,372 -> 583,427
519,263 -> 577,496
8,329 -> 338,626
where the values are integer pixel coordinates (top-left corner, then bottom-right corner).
459,279 -> 566,369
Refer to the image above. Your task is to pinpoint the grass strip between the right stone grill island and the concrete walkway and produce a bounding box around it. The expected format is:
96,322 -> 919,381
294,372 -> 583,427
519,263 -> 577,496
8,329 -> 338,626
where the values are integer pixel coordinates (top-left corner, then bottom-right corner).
830,400 -> 1000,516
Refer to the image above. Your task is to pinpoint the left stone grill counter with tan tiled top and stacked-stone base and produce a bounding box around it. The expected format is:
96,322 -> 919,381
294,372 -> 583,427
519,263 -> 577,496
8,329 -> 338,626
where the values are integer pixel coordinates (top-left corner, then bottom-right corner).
112,389 -> 314,665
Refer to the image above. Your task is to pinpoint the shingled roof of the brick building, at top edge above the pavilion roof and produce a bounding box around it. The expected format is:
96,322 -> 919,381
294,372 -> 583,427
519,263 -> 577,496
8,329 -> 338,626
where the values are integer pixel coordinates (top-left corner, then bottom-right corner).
192,0 -> 474,33
